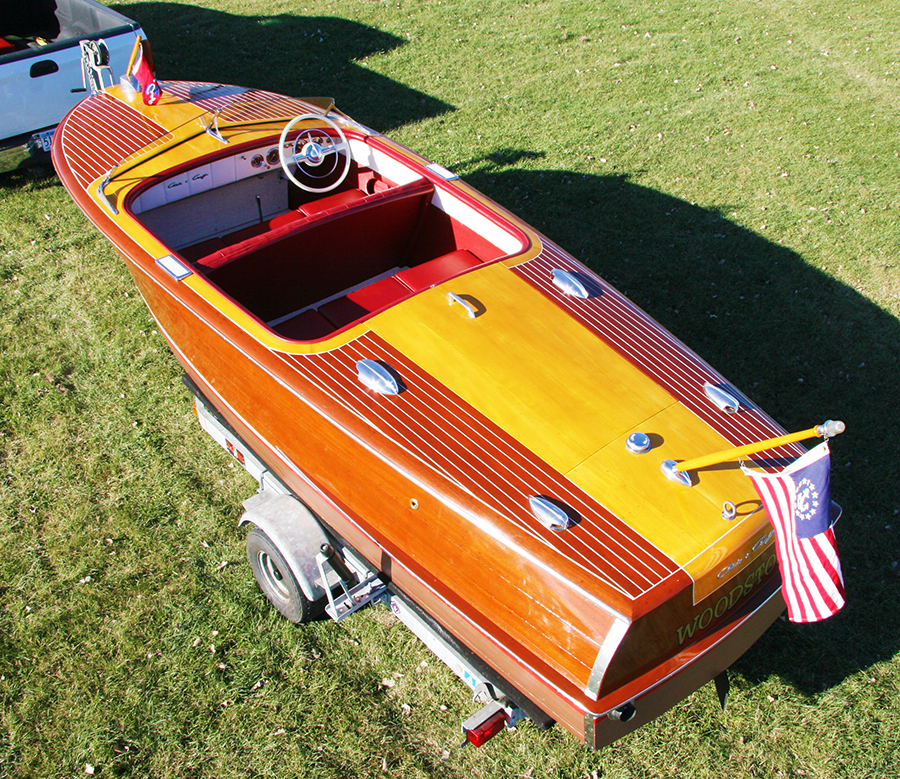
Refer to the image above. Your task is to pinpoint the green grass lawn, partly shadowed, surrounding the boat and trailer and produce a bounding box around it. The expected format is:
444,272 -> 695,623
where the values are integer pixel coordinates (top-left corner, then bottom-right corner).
0,0 -> 900,779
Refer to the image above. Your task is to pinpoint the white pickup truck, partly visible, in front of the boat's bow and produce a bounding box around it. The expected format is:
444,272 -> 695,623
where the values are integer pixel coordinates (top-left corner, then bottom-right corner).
0,0 -> 144,173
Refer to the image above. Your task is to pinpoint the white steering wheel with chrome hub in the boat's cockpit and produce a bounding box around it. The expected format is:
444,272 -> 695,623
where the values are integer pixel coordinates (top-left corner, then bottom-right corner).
278,114 -> 350,192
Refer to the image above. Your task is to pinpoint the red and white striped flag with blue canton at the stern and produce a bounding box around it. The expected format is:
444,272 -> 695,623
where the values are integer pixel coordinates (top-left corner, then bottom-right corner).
742,441 -> 844,622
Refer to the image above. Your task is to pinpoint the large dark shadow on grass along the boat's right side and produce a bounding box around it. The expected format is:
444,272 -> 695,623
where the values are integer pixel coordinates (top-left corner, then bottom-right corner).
459,161 -> 900,693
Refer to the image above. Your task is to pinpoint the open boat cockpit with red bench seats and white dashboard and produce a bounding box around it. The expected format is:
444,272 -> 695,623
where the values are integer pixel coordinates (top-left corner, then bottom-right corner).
127,114 -> 528,341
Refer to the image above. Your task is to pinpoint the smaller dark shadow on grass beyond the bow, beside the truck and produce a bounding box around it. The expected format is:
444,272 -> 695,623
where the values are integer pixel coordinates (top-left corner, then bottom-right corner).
113,3 -> 453,131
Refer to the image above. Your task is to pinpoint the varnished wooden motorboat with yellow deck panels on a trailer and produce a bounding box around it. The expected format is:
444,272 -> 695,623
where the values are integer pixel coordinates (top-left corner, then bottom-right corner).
53,77 -> 802,747
